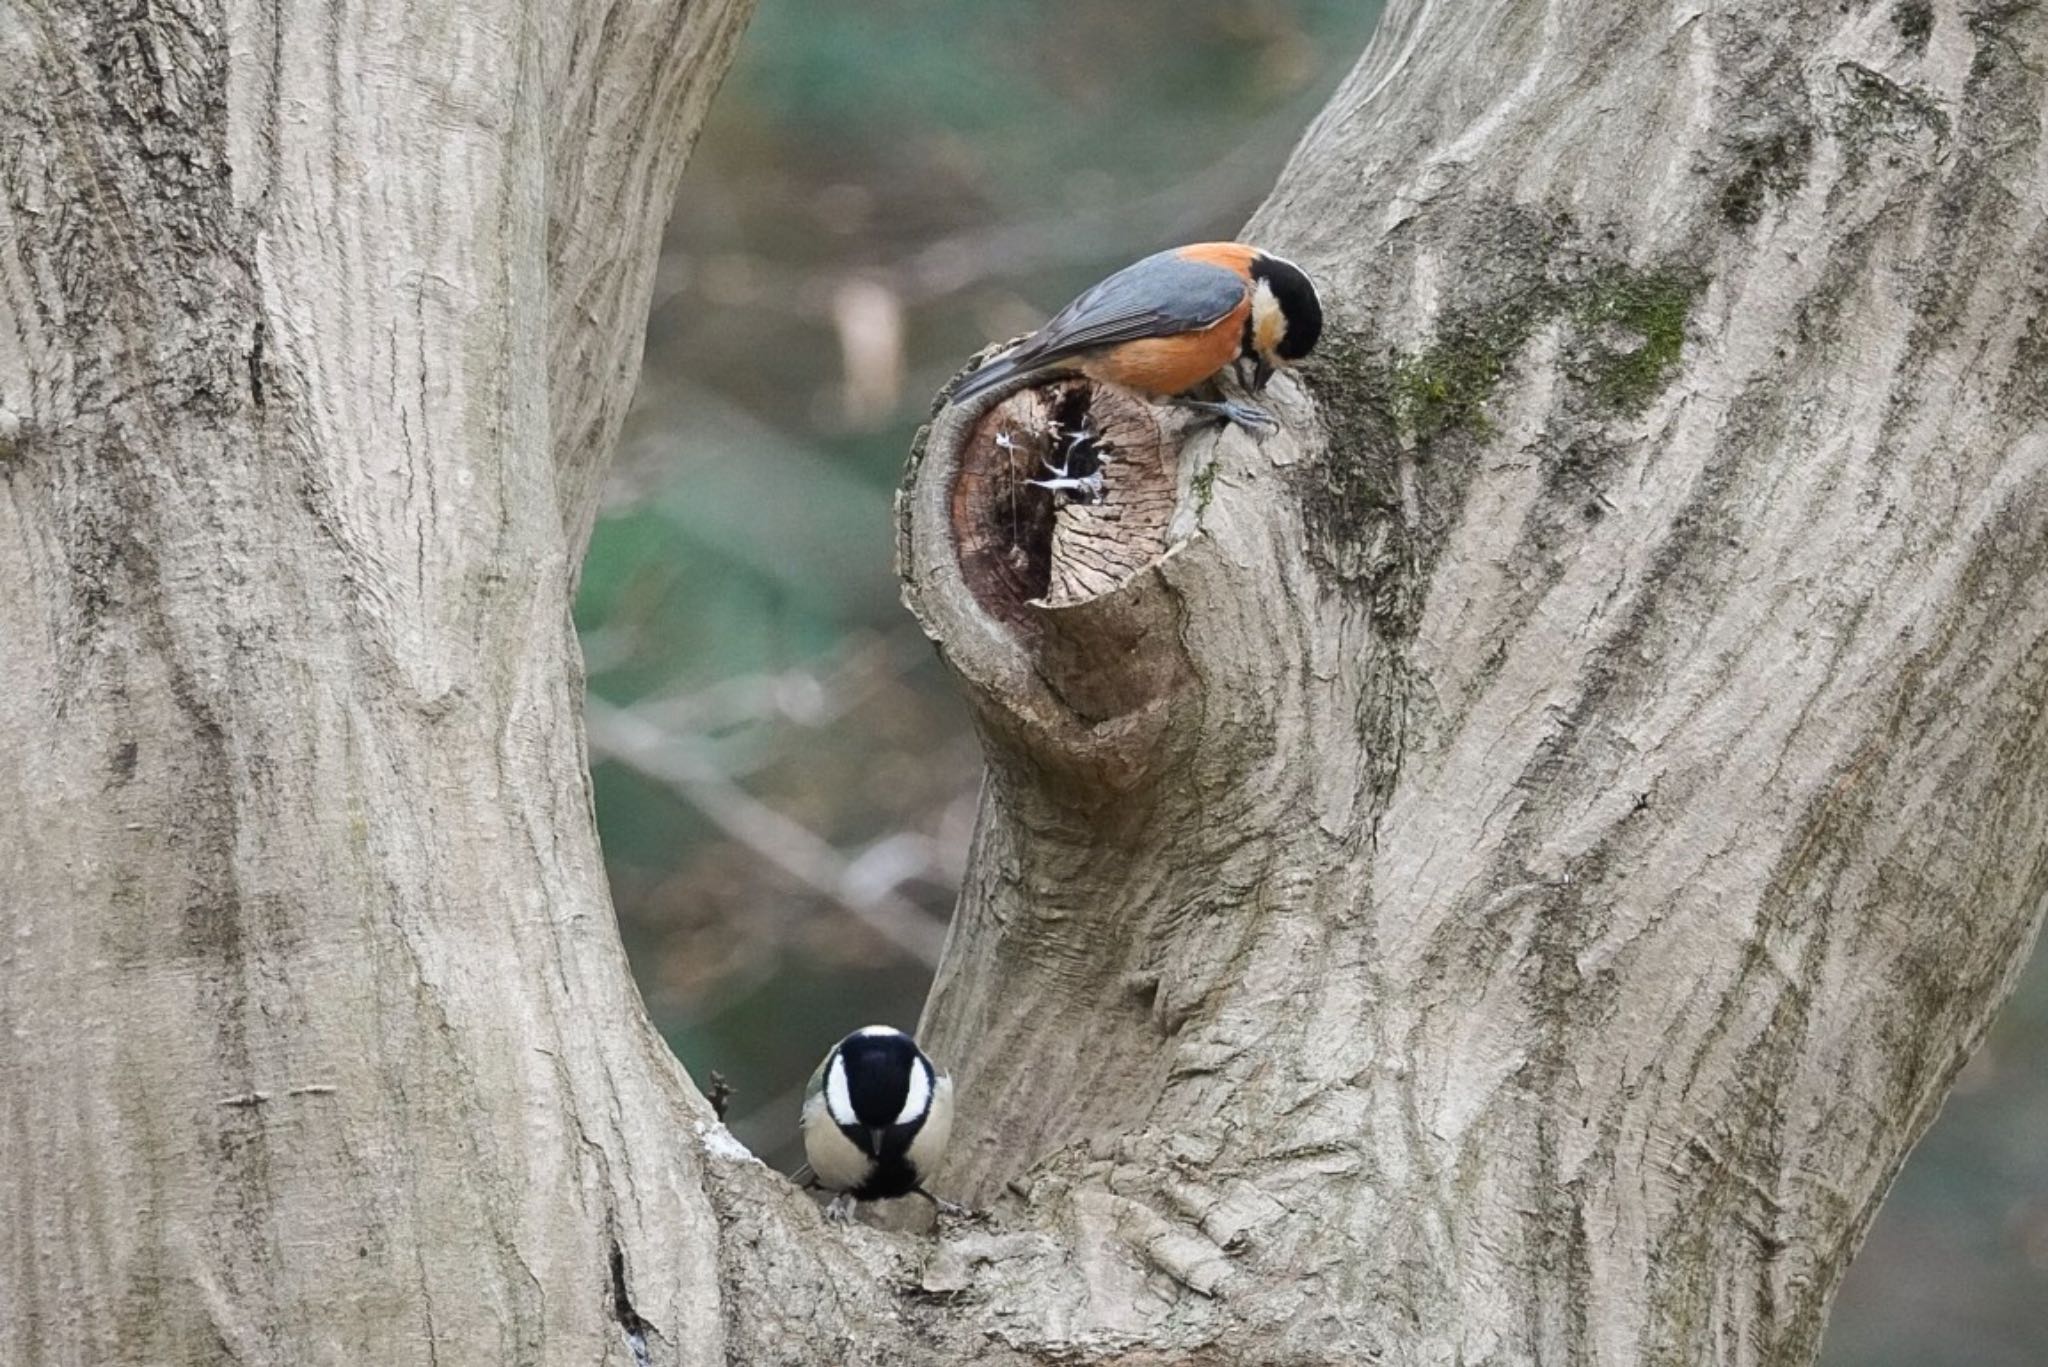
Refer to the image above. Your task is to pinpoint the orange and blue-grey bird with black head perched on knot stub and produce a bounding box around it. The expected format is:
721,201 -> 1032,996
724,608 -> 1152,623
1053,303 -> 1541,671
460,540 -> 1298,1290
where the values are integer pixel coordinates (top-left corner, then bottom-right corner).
952,242 -> 1323,428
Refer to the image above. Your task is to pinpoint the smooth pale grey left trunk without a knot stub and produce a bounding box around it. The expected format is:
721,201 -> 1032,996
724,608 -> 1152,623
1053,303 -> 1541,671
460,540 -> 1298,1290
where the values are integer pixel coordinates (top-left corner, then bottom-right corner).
0,0 -> 752,1365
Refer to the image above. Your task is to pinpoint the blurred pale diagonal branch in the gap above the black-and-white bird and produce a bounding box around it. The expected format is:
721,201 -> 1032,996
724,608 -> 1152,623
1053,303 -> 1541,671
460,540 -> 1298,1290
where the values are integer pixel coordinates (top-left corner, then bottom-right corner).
584,699 -> 946,967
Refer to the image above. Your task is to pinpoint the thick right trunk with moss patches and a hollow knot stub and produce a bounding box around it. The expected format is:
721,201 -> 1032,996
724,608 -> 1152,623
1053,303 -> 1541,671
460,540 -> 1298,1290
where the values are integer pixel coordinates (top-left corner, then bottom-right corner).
903,2 -> 2048,1367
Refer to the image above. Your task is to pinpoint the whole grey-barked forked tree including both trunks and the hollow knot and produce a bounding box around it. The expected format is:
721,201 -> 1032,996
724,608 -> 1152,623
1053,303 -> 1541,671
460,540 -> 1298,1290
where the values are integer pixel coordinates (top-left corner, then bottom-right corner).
0,0 -> 2048,1367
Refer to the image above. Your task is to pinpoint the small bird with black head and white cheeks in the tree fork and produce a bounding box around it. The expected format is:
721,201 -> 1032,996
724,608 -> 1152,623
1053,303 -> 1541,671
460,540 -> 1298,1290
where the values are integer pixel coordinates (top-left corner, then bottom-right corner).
799,1025 -> 961,1219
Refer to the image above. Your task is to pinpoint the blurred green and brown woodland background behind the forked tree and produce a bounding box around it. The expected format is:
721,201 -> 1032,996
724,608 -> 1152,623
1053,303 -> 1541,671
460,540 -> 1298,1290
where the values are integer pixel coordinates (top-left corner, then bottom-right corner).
578,0 -> 2048,1367
